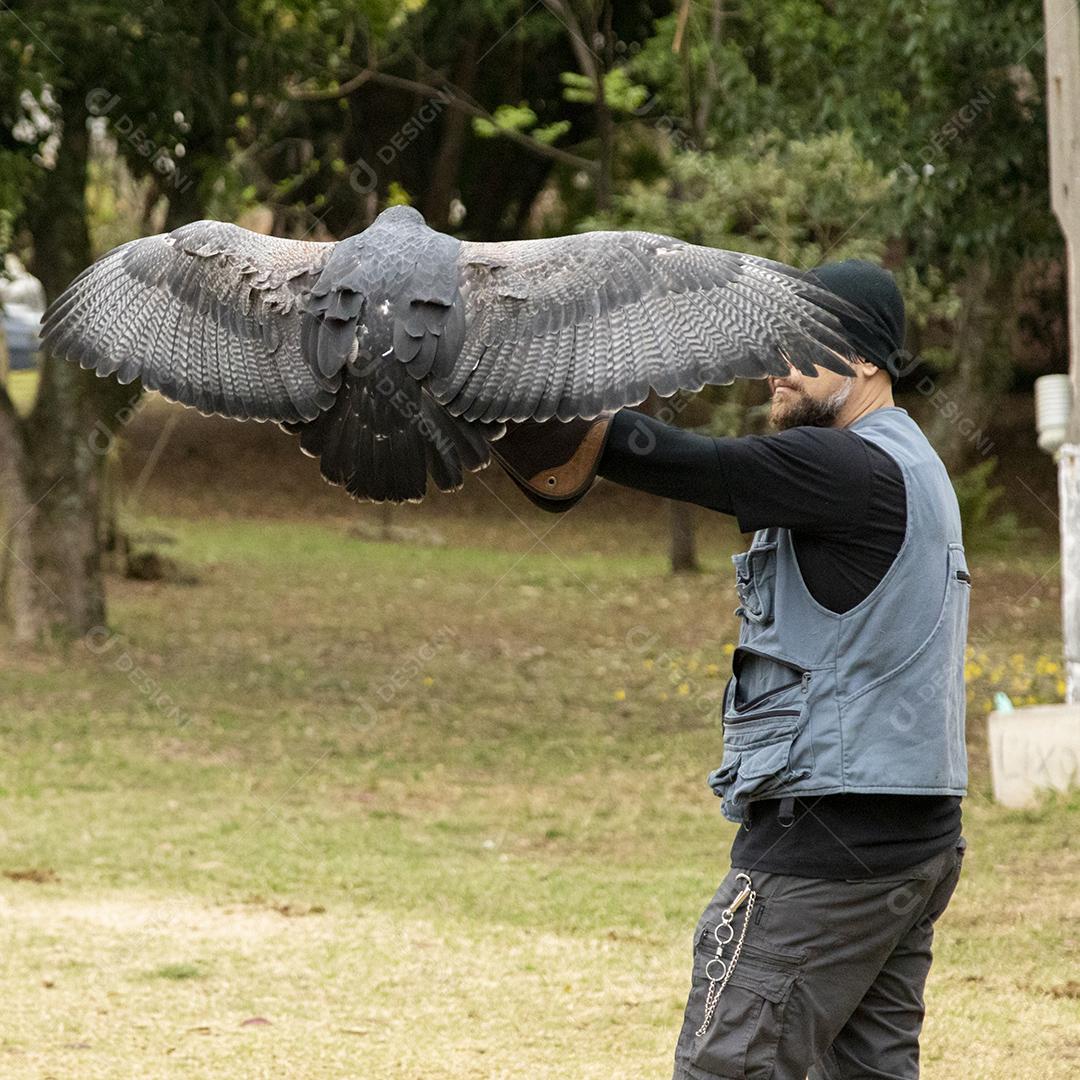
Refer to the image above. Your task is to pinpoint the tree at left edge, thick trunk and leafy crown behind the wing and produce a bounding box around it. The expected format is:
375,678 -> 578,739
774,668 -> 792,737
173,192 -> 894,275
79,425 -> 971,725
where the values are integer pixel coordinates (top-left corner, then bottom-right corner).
0,0 -> 396,640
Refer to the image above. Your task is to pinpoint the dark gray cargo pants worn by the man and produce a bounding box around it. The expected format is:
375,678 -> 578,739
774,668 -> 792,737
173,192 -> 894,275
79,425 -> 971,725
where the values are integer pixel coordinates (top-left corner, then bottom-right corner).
674,837 -> 967,1080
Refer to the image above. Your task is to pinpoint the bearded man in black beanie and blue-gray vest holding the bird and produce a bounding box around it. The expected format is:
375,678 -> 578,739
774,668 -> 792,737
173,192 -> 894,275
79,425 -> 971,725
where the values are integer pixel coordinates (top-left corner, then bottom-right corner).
494,260 -> 971,1080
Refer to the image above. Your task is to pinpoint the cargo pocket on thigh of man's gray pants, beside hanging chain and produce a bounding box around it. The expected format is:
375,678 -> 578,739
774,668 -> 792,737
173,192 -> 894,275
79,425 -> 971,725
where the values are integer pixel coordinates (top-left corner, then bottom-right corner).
681,933 -> 800,1080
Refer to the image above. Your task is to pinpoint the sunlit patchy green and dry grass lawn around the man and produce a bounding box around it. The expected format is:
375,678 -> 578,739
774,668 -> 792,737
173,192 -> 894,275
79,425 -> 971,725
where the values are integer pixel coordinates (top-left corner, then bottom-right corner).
0,512 -> 1080,1080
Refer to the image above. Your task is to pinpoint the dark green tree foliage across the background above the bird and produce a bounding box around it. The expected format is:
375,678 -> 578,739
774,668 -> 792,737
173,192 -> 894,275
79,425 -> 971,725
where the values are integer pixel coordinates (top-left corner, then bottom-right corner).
0,0 -> 1061,600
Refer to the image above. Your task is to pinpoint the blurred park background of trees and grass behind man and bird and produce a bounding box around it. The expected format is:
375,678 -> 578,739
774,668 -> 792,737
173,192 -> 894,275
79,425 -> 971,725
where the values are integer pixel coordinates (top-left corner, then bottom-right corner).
0,0 -> 1080,1080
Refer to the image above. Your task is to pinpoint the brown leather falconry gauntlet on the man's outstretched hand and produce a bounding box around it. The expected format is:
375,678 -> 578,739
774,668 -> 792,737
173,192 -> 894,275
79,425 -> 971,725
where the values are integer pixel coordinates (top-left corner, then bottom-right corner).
489,414 -> 611,513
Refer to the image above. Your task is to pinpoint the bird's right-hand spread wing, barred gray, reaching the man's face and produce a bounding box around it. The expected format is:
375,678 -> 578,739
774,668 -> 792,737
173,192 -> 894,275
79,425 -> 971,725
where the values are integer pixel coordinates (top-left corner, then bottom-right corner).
428,232 -> 881,421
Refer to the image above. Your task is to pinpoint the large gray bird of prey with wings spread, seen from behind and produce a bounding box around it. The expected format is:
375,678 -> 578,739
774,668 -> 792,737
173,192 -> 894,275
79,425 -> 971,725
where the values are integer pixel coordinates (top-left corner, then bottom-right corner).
42,206 -> 881,502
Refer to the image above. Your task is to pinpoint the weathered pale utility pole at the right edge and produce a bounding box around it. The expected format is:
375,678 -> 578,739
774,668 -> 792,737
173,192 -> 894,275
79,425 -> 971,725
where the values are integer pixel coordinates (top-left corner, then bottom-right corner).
1043,0 -> 1080,704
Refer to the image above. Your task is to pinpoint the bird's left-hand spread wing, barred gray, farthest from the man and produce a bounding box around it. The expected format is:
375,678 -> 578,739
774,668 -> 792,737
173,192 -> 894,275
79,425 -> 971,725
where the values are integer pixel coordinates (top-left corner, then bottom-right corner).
42,221 -> 341,422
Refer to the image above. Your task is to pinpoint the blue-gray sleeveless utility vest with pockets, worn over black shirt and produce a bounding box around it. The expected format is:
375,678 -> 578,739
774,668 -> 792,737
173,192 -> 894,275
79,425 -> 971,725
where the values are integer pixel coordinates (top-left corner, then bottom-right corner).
708,407 -> 971,822
